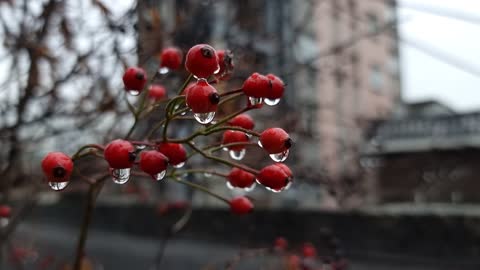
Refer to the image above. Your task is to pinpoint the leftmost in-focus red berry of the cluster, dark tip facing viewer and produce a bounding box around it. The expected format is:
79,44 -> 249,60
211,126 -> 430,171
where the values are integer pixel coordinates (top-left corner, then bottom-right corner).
42,152 -> 73,183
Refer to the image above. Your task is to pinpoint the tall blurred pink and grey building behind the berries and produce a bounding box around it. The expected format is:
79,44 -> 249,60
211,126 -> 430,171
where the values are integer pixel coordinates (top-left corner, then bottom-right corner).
138,0 -> 400,209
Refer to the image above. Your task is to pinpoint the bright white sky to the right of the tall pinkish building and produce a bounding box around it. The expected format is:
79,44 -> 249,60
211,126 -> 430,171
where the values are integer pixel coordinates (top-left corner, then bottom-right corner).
399,0 -> 480,111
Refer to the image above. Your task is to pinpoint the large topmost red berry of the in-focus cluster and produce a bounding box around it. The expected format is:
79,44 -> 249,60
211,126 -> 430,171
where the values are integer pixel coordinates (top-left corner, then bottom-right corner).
185,44 -> 220,79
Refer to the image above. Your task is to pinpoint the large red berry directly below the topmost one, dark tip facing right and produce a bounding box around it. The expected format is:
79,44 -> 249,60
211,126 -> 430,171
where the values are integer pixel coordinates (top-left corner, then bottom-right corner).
185,80 -> 220,113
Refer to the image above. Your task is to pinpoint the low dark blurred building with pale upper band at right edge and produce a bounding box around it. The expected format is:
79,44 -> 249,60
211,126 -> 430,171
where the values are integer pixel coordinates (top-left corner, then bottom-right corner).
361,101 -> 480,203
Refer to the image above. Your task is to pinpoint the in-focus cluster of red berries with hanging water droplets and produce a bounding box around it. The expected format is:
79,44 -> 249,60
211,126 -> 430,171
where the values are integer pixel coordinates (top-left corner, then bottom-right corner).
42,44 -> 293,214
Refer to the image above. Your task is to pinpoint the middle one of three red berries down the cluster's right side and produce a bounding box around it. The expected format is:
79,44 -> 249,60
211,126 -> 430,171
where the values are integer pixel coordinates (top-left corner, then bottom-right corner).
260,128 -> 293,154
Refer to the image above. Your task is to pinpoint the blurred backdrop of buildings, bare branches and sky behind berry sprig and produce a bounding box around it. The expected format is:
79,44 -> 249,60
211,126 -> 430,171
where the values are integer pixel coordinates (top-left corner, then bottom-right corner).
0,0 -> 480,269
